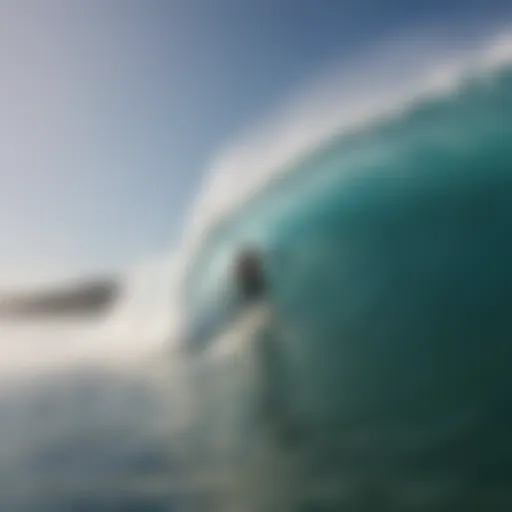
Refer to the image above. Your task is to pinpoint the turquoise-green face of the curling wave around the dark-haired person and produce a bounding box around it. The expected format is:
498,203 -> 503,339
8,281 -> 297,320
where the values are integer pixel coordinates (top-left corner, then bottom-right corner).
180,63 -> 512,512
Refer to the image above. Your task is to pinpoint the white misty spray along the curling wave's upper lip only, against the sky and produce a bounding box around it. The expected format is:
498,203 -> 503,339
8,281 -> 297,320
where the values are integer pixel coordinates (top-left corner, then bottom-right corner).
182,29 -> 512,266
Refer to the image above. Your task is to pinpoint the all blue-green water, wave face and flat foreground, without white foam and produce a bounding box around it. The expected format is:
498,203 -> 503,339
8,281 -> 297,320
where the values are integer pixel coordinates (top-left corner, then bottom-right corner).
0,46 -> 512,512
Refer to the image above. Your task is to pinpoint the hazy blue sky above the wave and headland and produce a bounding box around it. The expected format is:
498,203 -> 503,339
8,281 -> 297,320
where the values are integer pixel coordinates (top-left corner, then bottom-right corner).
0,0 -> 512,286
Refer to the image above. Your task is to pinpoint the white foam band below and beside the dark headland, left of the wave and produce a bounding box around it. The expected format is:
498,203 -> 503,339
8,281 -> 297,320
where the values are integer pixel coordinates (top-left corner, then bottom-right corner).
0,255 -> 181,378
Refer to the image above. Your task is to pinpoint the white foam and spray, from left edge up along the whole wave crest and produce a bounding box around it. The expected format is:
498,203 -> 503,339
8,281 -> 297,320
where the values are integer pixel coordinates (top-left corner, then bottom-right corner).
4,30 -> 512,371
